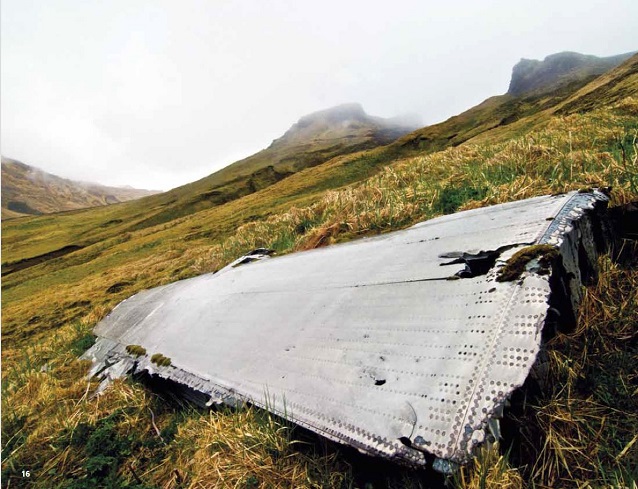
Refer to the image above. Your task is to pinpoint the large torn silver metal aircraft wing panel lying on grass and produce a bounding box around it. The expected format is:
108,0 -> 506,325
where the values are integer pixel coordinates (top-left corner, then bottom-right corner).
85,191 -> 607,471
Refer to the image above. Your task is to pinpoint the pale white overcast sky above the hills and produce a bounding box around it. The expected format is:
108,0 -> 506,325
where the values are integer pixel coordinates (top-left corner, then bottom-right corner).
0,0 -> 638,189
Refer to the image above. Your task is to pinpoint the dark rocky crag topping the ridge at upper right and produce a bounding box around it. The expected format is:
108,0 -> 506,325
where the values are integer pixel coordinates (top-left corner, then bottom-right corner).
507,51 -> 635,96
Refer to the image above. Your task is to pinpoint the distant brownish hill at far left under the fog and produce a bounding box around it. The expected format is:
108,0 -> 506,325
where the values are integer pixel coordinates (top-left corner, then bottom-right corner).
2,157 -> 158,219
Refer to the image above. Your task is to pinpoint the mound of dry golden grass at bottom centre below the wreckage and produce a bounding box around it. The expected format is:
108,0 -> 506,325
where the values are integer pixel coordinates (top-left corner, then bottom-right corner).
148,408 -> 352,487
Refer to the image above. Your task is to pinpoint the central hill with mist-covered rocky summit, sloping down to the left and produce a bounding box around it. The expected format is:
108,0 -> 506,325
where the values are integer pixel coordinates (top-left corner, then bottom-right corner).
115,103 -> 418,229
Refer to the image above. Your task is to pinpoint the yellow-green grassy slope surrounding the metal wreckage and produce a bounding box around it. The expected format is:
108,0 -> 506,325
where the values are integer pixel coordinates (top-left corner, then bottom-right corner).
2,57 -> 638,488
